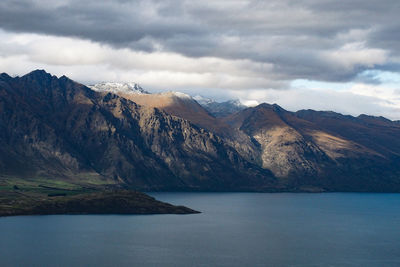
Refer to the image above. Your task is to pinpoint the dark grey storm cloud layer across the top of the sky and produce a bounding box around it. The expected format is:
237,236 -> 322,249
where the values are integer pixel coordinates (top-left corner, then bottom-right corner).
0,0 -> 400,81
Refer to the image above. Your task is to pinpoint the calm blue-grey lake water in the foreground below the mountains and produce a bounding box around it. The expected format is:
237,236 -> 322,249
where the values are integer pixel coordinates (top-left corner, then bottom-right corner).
0,193 -> 400,266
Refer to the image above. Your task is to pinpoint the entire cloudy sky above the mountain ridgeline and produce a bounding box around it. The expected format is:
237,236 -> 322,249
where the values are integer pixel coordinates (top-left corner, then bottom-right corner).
0,0 -> 400,120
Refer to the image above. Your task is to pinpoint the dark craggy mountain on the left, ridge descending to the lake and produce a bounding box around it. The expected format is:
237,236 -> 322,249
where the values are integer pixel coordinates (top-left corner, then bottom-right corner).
0,70 -> 275,190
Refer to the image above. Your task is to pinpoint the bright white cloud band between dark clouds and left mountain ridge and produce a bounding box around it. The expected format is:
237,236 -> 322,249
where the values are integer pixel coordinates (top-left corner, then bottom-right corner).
0,31 -> 287,90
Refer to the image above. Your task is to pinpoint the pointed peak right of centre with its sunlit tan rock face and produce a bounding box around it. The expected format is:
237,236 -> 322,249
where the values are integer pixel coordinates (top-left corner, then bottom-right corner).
226,104 -> 328,179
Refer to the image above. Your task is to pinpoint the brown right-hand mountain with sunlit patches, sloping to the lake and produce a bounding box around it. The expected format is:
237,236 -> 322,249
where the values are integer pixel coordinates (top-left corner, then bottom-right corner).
225,104 -> 400,191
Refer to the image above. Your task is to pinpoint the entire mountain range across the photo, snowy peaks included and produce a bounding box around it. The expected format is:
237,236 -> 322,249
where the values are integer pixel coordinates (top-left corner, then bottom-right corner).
0,70 -> 400,192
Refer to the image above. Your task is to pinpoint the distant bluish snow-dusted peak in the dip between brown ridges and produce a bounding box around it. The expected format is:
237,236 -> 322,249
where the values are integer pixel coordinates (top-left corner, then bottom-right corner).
194,95 -> 246,117
